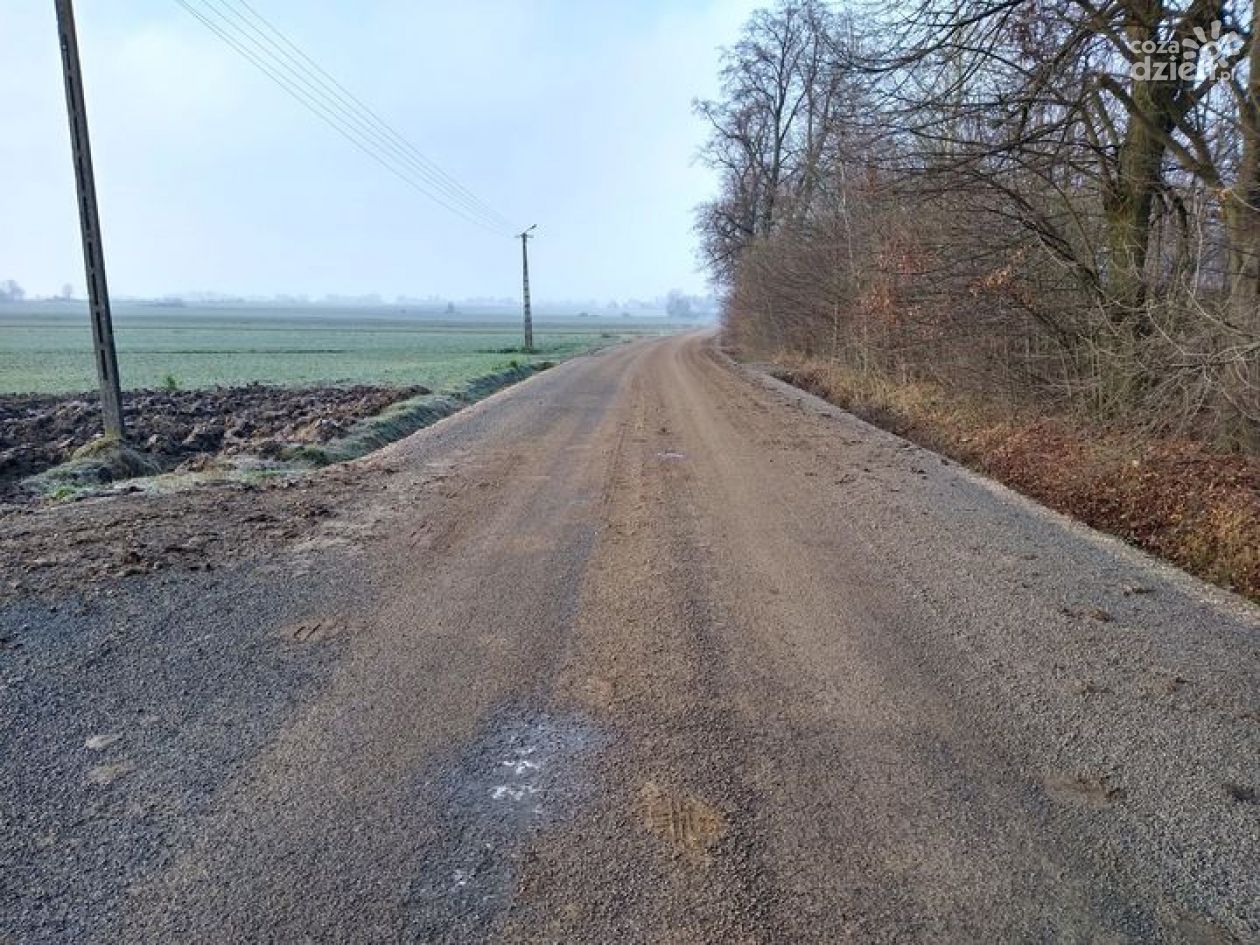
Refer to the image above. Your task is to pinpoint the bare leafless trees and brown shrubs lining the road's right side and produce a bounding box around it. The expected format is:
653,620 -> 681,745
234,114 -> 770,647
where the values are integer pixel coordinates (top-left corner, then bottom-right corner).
697,0 -> 1260,449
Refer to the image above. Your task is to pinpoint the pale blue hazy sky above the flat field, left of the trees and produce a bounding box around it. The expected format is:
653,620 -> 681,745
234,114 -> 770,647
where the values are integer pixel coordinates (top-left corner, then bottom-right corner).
0,0 -> 757,299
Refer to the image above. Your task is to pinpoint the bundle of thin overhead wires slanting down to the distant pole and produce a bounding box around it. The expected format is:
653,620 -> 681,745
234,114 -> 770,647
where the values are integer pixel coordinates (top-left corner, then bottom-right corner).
175,0 -> 512,234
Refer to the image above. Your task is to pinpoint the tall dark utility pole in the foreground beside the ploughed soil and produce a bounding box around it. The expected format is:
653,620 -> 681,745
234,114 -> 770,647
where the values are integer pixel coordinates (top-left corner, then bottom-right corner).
54,0 -> 123,438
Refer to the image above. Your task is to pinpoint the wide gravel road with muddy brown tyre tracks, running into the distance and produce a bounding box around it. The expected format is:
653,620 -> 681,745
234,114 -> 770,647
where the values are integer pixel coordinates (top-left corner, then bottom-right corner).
0,334 -> 1260,944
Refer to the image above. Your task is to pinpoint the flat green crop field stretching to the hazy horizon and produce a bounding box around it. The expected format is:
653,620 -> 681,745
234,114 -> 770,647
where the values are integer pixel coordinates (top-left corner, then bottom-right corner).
0,302 -> 679,393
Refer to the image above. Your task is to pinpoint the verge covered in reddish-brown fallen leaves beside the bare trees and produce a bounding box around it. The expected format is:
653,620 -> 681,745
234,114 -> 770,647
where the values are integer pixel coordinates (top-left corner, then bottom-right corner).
779,359 -> 1260,602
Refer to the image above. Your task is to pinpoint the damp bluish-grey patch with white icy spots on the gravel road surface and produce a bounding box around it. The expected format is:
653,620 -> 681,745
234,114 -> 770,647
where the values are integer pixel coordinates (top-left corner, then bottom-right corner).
400,708 -> 607,942
